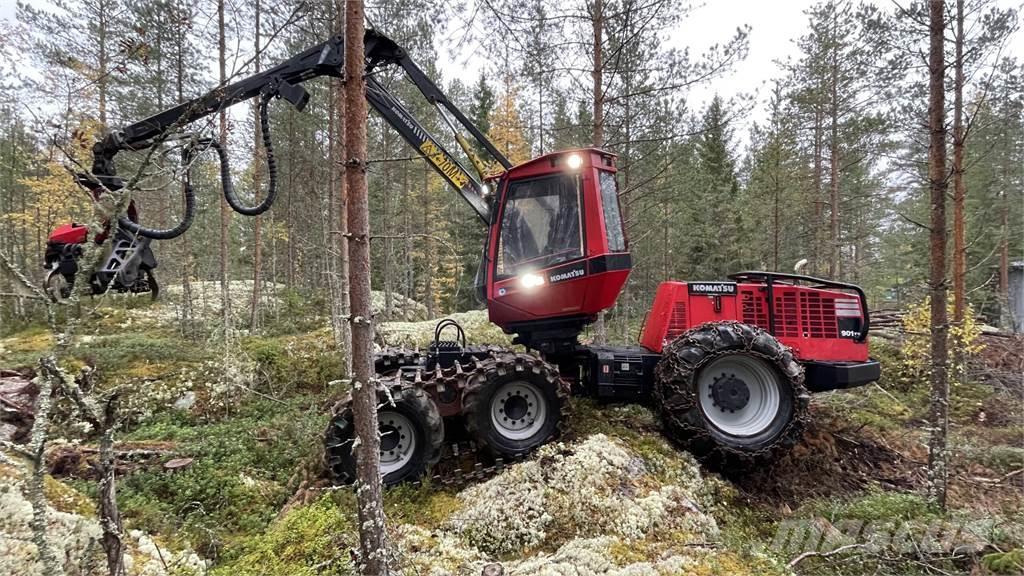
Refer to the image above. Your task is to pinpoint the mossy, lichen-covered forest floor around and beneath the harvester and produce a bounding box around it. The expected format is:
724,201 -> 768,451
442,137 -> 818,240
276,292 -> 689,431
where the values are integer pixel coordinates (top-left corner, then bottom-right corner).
0,290 -> 1024,576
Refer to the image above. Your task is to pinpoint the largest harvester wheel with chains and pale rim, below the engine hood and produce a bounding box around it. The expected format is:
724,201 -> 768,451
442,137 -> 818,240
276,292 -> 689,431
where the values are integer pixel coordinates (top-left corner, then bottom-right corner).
654,322 -> 810,466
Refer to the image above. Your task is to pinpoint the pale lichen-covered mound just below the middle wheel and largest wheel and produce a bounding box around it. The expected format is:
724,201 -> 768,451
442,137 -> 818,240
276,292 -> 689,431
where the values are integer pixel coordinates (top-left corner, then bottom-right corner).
449,435 -> 718,554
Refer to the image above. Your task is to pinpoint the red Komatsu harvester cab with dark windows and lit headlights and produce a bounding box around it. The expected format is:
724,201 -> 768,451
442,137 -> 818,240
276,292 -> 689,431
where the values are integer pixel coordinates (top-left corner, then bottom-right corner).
482,149 -> 631,352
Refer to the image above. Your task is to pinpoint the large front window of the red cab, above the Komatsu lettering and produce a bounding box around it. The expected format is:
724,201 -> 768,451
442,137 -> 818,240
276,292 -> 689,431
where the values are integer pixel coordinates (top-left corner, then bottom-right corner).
498,174 -> 583,277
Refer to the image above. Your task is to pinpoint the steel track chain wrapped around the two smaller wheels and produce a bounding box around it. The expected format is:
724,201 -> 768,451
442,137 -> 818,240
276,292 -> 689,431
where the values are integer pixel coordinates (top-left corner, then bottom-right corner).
325,345 -> 571,488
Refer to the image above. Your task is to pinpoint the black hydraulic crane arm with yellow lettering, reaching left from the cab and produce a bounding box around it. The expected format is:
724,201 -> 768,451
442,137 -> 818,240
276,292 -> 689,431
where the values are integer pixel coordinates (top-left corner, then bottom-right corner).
90,30 -> 511,225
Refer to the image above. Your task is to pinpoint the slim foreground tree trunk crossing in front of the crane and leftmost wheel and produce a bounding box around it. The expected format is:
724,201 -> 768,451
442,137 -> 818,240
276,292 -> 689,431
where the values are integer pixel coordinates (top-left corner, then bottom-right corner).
345,0 -> 388,576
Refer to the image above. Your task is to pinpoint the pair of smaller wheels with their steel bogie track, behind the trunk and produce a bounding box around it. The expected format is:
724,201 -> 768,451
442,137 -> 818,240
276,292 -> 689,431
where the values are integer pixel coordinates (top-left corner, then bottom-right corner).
325,346 -> 569,485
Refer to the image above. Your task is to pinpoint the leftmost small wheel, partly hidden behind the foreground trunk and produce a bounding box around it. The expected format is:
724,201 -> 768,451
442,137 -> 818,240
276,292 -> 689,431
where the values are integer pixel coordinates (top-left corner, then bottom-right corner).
324,381 -> 444,486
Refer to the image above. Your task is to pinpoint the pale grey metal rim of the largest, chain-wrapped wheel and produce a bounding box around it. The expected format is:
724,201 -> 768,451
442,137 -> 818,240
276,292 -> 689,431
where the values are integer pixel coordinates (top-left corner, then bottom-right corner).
697,355 -> 781,437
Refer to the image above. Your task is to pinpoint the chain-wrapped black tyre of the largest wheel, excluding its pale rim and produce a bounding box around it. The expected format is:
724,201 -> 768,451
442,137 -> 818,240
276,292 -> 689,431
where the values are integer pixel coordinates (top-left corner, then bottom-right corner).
654,321 -> 810,464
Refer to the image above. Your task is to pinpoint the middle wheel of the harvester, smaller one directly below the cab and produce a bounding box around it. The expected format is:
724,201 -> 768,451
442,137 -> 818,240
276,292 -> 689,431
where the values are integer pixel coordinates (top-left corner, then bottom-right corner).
463,353 -> 569,457
